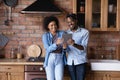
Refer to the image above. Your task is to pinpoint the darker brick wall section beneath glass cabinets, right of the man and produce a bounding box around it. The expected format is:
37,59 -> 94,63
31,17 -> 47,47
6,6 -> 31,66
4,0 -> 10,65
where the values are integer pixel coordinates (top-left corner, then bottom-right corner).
88,31 -> 120,59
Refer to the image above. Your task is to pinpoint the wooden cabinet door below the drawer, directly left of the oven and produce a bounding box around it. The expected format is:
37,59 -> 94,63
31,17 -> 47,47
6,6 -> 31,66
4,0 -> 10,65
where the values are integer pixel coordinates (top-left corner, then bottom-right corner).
8,72 -> 24,80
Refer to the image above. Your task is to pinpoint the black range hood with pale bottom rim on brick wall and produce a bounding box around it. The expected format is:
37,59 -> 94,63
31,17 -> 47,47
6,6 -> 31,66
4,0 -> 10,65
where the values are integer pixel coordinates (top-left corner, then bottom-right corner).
21,0 -> 63,14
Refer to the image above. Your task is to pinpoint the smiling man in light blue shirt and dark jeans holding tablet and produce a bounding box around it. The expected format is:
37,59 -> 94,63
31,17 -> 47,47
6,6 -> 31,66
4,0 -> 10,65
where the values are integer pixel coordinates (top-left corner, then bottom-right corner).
66,14 -> 89,80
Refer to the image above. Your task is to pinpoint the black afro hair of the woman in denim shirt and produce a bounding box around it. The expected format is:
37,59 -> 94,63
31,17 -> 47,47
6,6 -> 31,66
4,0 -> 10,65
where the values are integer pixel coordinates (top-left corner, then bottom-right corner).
43,15 -> 59,31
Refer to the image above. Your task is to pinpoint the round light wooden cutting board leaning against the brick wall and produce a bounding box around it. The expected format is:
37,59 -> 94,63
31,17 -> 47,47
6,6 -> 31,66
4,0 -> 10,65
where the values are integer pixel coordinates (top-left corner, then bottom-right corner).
27,44 -> 41,58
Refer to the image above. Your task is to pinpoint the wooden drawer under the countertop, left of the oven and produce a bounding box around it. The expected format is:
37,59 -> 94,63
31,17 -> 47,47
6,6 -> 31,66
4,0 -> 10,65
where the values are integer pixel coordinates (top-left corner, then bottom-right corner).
0,65 -> 24,72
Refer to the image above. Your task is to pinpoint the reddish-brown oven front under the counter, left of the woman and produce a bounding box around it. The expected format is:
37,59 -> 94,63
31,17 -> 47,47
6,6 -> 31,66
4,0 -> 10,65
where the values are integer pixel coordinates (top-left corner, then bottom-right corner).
25,65 -> 47,80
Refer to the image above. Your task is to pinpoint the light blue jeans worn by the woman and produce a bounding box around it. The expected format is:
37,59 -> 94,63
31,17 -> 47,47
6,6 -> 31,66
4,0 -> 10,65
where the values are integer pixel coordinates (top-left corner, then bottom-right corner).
45,53 -> 64,80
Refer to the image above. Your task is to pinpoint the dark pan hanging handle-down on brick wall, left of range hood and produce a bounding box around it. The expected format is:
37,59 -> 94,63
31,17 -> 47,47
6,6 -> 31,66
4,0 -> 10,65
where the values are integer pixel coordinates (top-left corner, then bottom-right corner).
3,0 -> 18,21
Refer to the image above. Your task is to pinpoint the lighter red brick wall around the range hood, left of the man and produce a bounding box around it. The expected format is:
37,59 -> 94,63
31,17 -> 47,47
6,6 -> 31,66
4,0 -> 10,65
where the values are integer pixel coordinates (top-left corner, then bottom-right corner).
0,0 -> 72,58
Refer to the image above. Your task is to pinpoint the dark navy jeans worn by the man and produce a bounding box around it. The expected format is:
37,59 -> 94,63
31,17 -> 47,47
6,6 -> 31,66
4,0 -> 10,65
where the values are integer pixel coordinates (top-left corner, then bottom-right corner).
68,63 -> 86,80
